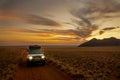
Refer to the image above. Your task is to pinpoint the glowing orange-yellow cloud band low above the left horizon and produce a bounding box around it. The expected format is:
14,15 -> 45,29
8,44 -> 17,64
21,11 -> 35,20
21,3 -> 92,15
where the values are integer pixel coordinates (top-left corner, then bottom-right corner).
0,28 -> 81,44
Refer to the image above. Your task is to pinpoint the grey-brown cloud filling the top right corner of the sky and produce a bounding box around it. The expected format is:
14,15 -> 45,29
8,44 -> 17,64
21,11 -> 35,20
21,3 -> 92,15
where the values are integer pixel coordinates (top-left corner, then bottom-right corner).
75,0 -> 120,15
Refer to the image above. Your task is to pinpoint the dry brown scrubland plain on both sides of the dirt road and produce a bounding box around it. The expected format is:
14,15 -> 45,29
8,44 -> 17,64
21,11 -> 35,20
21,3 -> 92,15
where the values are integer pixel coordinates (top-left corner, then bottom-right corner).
0,47 -> 120,80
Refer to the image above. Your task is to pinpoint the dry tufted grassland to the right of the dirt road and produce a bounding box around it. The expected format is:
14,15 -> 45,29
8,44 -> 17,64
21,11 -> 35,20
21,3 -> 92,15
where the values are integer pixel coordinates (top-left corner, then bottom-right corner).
44,47 -> 120,80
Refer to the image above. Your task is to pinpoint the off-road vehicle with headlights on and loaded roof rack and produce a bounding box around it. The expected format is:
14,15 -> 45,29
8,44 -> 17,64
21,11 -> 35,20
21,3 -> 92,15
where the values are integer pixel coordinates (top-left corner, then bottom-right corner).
27,45 -> 46,65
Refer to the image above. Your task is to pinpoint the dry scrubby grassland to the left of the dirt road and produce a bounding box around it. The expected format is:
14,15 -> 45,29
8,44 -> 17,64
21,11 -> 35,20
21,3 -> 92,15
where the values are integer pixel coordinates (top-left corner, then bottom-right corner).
0,47 -> 21,80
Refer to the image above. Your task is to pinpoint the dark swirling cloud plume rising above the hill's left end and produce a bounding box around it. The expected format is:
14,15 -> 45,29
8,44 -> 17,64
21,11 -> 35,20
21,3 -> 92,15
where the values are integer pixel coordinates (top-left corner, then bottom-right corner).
70,0 -> 101,38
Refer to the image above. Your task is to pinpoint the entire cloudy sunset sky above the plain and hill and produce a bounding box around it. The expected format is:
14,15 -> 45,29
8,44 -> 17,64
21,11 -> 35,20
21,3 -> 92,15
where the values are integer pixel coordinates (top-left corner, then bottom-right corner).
0,0 -> 120,45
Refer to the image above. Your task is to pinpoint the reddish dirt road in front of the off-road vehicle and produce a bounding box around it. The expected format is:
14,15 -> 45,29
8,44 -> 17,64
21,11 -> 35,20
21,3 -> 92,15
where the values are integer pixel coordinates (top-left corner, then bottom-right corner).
15,51 -> 72,80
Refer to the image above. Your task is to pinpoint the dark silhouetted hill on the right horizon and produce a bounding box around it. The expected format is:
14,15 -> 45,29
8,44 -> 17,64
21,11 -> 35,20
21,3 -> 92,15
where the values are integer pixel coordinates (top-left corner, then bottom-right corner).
79,37 -> 120,47
